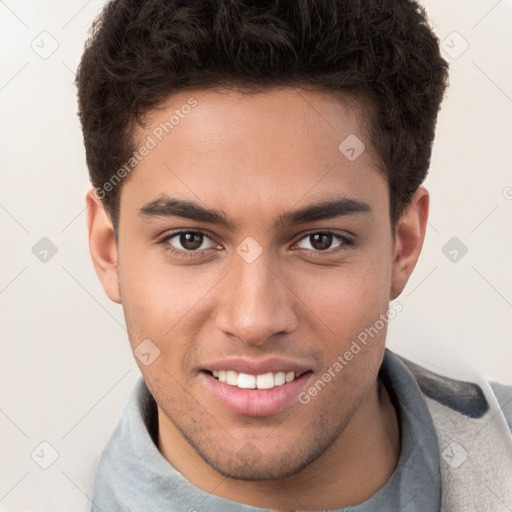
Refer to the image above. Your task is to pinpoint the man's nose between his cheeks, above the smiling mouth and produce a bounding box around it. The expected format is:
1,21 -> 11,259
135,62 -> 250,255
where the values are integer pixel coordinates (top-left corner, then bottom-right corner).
215,249 -> 297,346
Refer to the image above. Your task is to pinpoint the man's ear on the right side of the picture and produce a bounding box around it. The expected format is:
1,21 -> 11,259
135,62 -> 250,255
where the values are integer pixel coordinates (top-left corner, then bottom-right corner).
390,187 -> 429,300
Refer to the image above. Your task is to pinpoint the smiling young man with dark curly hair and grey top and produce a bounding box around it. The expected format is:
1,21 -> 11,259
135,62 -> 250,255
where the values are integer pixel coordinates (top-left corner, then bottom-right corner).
77,0 -> 512,512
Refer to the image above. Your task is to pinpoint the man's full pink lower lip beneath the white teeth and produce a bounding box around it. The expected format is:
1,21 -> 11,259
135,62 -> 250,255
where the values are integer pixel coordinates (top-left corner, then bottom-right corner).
202,372 -> 311,417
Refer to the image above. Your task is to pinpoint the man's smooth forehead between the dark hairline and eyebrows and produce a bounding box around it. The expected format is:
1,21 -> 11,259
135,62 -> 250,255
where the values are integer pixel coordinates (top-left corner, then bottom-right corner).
121,88 -> 387,224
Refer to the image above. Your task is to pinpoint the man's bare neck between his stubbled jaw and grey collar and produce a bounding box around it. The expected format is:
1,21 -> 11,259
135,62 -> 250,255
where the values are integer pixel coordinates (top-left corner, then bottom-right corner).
158,381 -> 400,510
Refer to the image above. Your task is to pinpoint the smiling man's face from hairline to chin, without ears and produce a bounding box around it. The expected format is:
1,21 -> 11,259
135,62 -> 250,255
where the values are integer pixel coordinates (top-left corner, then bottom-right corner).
89,88 -> 424,480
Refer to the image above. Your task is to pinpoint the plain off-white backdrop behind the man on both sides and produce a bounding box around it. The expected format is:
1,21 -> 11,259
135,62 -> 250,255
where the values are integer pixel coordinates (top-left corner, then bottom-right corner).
0,0 -> 512,512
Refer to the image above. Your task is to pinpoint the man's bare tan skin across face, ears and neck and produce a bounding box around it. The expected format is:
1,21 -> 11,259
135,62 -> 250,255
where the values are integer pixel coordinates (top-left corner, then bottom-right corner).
87,88 -> 429,510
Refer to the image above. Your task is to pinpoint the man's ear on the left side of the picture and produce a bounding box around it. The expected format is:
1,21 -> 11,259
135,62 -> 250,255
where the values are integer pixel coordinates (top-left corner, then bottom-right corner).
85,189 -> 121,304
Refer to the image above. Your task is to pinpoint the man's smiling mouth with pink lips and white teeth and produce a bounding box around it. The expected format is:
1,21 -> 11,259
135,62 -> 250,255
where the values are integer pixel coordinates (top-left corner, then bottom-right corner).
200,366 -> 313,417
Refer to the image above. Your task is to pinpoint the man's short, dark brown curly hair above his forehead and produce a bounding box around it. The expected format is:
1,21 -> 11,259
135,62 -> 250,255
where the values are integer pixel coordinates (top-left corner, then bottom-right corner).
76,0 -> 448,230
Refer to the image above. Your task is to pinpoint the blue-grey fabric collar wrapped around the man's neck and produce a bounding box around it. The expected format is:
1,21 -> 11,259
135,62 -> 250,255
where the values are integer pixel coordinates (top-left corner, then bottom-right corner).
91,349 -> 441,512
